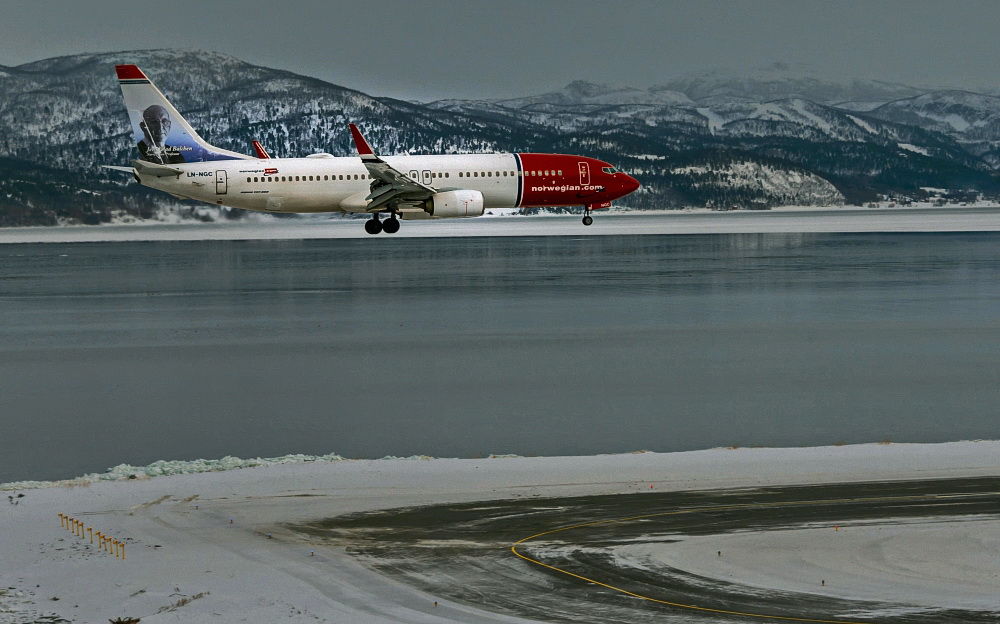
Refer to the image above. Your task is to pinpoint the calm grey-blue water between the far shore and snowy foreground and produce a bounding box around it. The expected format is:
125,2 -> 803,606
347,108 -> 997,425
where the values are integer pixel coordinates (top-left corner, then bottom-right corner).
0,233 -> 1000,482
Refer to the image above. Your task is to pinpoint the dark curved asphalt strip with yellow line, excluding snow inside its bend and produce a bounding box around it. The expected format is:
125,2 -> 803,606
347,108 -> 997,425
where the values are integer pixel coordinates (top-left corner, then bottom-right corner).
293,478 -> 1000,624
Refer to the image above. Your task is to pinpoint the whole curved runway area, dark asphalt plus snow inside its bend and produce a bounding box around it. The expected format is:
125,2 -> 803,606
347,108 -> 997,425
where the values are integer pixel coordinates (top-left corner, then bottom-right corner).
293,478 -> 1000,624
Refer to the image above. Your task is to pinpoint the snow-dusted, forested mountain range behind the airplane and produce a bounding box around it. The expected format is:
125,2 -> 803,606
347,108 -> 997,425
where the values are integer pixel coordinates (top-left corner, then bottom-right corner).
0,50 -> 1000,224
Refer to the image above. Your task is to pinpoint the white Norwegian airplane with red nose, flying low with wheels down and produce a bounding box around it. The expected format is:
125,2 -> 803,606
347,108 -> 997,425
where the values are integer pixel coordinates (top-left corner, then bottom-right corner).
105,65 -> 639,234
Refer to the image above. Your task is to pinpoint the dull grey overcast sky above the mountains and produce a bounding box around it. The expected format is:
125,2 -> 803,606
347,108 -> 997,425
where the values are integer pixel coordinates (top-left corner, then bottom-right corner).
0,0 -> 1000,100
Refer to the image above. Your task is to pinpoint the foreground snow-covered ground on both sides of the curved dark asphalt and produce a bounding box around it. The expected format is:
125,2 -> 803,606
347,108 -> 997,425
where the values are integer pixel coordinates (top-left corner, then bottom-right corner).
0,441 -> 1000,624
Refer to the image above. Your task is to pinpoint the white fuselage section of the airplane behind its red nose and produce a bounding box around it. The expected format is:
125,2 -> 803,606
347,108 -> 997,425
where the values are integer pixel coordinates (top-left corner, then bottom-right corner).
149,154 -> 524,212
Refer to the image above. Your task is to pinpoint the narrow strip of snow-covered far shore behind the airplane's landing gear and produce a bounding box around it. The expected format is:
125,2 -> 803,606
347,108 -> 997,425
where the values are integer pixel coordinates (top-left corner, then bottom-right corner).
0,204 -> 1000,244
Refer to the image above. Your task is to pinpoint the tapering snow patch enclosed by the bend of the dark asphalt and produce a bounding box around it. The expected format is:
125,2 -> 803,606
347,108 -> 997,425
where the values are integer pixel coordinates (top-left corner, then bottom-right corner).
615,516 -> 1000,610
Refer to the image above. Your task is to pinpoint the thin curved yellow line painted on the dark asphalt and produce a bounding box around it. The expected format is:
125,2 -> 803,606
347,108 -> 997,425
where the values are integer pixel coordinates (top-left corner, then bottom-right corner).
510,494 -> 976,624
